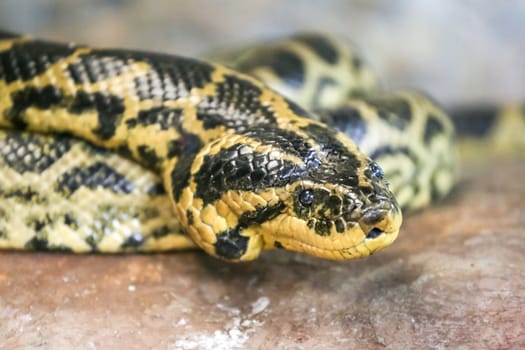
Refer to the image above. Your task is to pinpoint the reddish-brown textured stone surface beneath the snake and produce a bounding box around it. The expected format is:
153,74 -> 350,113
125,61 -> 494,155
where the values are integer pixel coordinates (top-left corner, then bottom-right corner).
0,159 -> 525,349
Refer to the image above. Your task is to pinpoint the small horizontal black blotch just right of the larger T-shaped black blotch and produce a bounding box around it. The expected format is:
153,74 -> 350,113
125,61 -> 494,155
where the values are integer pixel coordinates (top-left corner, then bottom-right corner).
126,107 -> 183,130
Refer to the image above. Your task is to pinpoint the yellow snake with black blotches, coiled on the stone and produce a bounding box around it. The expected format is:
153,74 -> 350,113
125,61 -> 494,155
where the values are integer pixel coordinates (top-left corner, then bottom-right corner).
0,31 -> 516,262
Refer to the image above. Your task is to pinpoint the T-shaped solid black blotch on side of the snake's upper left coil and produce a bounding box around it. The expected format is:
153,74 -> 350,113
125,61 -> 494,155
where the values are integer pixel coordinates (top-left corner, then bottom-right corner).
69,91 -> 125,140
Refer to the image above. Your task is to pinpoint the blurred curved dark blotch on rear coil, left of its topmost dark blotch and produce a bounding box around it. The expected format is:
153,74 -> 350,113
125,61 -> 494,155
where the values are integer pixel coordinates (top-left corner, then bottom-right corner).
236,48 -> 305,90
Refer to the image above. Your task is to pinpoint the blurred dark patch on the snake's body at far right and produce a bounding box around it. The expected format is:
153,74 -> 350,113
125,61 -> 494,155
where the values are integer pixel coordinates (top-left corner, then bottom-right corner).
449,105 -> 500,137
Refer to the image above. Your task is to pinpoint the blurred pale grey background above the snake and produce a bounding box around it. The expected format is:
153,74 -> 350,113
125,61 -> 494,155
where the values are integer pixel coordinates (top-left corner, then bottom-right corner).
0,0 -> 525,105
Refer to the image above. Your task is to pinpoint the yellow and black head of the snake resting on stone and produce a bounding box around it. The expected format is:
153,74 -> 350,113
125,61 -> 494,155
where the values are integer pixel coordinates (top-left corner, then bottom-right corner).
176,122 -> 401,261
